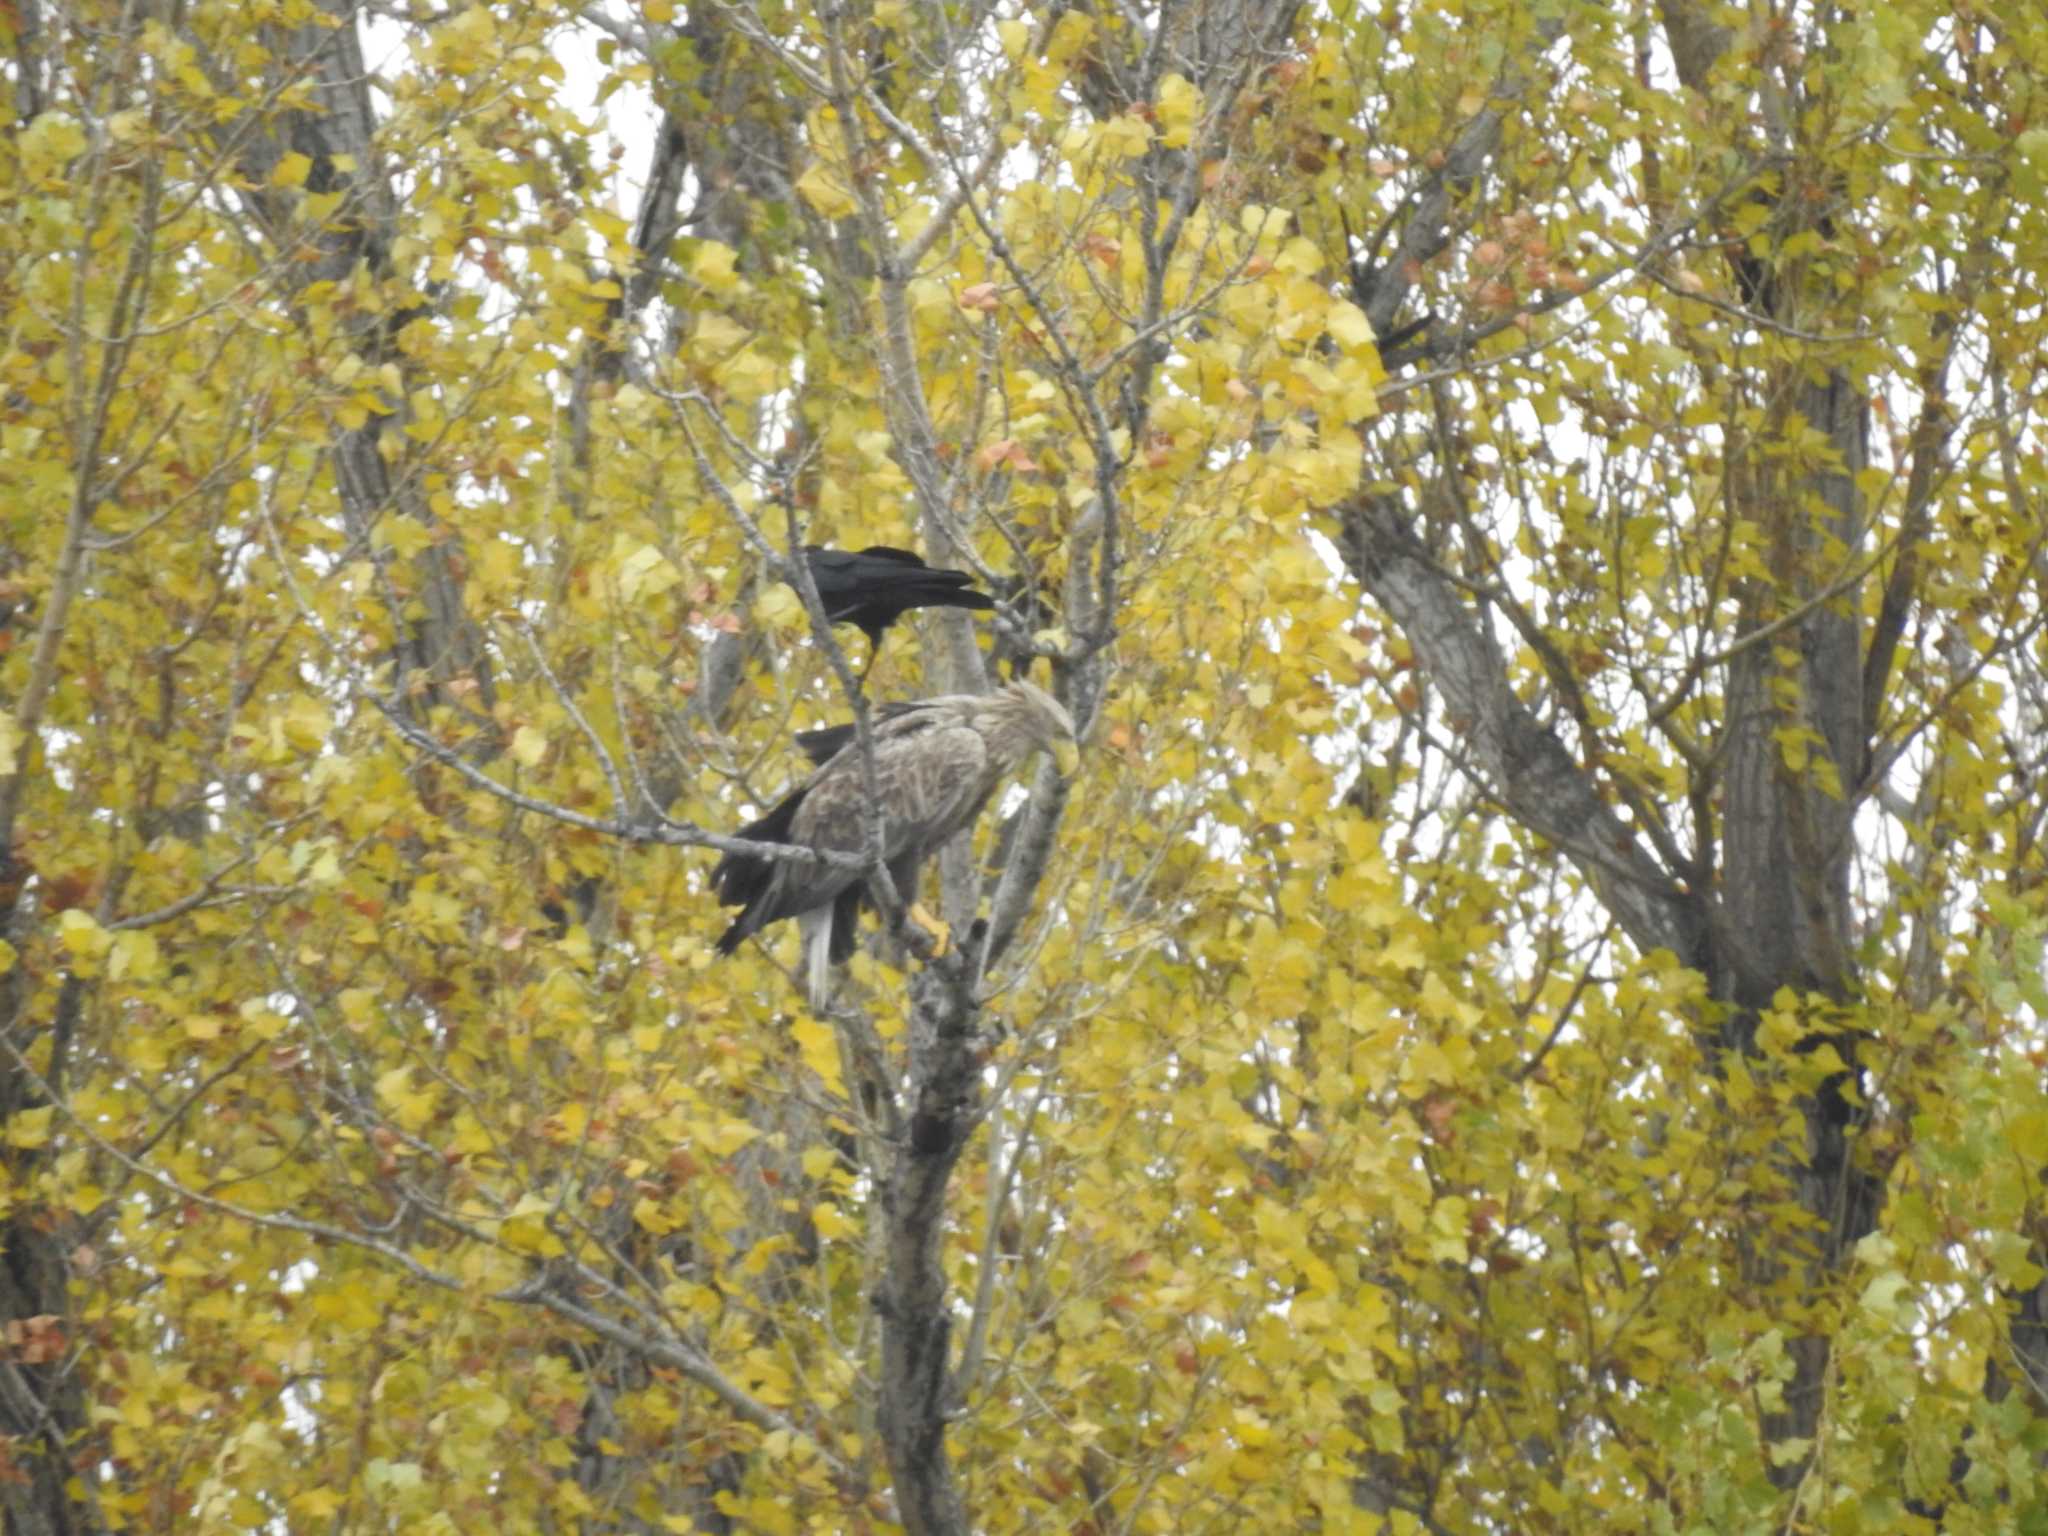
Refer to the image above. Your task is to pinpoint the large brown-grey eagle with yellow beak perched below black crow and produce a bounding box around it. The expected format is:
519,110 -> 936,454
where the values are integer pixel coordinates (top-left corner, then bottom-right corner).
711,682 -> 1073,1004
